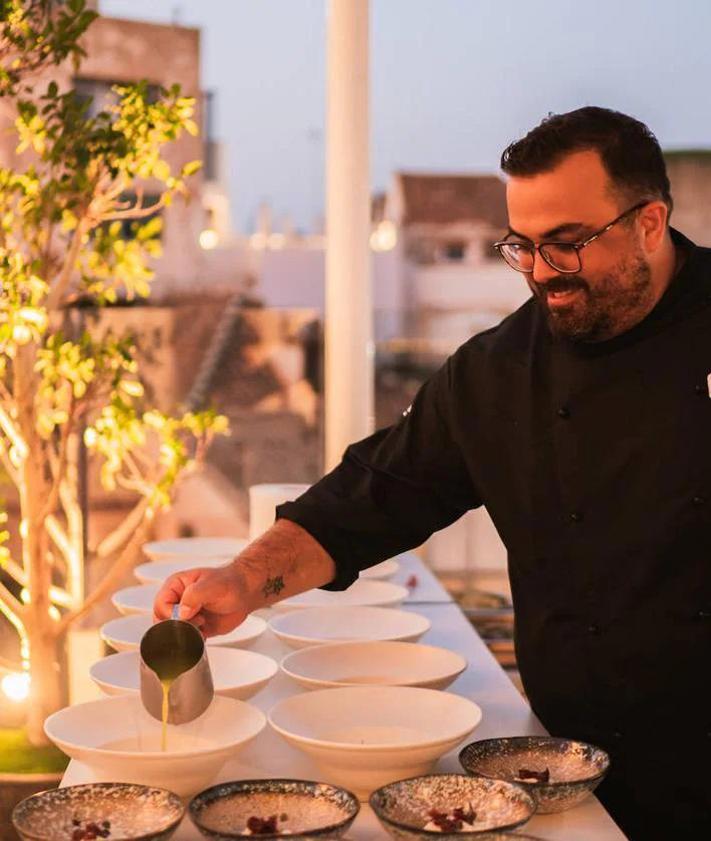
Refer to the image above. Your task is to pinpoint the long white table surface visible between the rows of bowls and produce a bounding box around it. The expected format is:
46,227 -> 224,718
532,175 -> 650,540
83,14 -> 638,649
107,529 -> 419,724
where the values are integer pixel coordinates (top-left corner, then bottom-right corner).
61,553 -> 625,841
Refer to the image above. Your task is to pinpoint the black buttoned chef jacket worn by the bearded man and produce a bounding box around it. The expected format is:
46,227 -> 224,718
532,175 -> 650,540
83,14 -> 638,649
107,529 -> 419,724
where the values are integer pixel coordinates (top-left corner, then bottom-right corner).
278,226 -> 711,841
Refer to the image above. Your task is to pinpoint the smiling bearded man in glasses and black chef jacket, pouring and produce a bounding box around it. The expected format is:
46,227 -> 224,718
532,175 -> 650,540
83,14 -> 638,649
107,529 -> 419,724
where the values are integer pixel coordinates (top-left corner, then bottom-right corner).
155,108 -> 711,841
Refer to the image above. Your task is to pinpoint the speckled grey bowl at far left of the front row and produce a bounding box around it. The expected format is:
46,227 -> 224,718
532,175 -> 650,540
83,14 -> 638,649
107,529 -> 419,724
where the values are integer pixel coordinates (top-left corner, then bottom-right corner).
12,783 -> 185,841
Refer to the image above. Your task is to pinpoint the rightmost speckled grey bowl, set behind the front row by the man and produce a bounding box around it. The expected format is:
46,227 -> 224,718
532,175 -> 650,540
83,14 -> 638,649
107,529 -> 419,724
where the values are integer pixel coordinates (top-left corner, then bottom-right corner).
459,736 -> 610,814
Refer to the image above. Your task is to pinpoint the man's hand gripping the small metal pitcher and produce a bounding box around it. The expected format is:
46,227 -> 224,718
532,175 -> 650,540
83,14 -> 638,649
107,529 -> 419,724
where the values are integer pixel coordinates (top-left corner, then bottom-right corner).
153,562 -> 252,637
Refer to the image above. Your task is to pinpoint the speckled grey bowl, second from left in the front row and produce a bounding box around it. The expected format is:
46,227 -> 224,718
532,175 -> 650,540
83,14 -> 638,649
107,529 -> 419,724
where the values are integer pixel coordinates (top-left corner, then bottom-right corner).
188,780 -> 360,841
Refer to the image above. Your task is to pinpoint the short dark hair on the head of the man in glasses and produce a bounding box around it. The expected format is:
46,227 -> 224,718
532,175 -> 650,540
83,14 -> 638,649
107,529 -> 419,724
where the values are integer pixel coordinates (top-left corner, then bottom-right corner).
501,106 -> 673,213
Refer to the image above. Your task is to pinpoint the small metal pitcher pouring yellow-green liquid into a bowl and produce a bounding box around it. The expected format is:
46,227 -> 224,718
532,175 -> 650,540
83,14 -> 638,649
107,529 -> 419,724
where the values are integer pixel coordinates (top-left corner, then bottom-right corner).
140,610 -> 215,724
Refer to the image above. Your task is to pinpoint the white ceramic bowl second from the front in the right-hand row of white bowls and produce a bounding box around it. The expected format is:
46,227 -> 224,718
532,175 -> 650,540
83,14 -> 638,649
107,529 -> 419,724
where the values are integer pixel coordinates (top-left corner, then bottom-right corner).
281,642 -> 467,689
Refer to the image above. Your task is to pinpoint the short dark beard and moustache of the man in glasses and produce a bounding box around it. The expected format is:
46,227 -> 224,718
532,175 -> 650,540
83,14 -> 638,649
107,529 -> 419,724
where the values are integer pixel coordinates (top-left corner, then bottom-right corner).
528,253 -> 656,342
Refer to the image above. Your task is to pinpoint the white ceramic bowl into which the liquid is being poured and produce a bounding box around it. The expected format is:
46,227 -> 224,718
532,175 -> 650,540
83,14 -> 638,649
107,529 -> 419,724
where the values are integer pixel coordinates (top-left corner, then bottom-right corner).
44,695 -> 265,797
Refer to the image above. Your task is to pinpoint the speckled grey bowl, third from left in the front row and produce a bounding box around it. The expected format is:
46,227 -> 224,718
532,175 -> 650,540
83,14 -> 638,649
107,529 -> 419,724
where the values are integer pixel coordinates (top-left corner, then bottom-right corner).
370,774 -> 536,841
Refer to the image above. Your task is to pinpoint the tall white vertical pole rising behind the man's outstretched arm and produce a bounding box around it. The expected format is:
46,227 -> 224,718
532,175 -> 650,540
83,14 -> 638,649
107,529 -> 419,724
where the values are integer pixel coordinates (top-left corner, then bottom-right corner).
325,0 -> 373,470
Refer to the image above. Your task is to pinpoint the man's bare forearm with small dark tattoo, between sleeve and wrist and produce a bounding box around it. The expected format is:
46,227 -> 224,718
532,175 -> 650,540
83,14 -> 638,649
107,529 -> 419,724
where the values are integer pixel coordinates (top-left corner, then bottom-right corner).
232,519 -> 336,610
